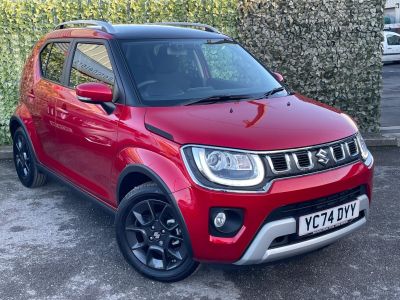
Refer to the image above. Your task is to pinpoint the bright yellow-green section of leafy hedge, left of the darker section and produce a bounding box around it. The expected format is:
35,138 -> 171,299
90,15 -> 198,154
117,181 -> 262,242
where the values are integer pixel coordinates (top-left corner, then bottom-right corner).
0,0 -> 238,145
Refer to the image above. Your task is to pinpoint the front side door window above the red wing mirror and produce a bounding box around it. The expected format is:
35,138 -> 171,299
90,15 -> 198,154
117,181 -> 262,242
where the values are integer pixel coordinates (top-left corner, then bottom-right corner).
69,43 -> 115,88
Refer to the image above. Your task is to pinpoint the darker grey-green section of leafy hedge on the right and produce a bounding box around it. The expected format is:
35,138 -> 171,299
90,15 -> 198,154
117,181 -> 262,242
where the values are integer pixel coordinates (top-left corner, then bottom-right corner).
238,0 -> 384,132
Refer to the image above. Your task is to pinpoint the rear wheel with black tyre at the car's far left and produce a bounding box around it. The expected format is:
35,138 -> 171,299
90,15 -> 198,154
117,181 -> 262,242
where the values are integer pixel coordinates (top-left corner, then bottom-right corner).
13,127 -> 47,188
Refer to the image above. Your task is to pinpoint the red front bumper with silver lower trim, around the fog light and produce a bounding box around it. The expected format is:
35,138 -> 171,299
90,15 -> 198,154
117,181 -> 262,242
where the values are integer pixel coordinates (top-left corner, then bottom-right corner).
173,161 -> 373,264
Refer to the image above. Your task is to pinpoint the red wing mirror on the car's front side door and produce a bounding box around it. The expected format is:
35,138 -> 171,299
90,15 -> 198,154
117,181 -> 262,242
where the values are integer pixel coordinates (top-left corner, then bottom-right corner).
76,82 -> 113,104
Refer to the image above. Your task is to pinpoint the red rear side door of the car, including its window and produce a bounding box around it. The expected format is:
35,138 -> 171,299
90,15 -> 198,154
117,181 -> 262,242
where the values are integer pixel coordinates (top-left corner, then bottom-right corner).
32,41 -> 70,169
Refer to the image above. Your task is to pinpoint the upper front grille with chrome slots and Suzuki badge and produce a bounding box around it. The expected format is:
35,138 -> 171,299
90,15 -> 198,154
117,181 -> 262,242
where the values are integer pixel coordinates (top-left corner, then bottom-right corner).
264,136 -> 360,179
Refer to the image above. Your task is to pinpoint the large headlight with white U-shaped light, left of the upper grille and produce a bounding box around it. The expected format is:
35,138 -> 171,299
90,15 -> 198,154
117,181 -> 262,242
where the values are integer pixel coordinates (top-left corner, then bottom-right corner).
185,147 -> 265,187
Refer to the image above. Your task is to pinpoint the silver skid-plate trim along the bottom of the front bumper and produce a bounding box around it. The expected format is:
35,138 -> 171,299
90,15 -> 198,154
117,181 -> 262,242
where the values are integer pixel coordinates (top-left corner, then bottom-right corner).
235,195 -> 369,265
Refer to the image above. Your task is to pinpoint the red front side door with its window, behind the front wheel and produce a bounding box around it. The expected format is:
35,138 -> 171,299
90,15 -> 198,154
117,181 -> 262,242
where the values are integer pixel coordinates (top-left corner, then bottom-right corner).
56,40 -> 118,201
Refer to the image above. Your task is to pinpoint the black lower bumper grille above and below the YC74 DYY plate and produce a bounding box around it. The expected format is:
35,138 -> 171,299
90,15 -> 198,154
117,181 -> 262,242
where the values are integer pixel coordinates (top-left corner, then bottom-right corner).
264,186 -> 366,248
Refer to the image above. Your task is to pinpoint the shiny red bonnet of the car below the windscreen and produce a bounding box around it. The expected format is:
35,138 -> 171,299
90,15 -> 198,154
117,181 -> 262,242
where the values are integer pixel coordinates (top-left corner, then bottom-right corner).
145,94 -> 357,150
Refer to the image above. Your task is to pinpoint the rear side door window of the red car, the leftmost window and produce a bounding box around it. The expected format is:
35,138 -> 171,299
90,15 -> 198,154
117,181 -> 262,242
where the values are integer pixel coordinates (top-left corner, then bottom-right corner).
40,43 -> 69,83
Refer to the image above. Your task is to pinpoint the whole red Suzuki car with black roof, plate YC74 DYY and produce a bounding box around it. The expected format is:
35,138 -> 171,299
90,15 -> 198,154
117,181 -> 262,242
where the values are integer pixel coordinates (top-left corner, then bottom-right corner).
10,21 -> 373,281
